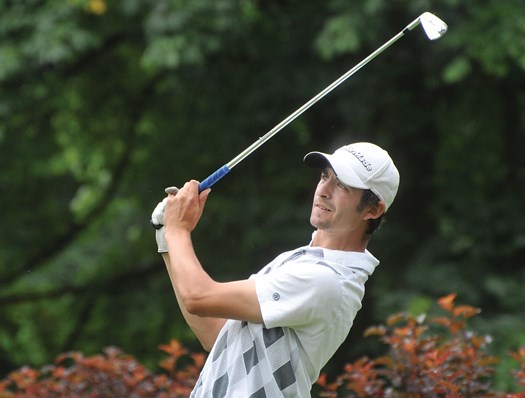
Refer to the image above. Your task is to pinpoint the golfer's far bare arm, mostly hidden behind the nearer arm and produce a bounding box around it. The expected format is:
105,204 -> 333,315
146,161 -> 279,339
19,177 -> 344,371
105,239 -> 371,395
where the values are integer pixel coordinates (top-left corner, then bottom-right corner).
162,253 -> 226,351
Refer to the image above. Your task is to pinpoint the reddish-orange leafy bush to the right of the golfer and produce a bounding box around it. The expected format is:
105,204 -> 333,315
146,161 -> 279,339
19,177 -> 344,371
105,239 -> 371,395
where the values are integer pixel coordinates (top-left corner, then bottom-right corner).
318,294 -> 525,398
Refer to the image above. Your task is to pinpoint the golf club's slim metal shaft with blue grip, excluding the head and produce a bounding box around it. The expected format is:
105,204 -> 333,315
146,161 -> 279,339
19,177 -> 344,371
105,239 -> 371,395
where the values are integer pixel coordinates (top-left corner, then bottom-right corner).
199,18 -> 419,191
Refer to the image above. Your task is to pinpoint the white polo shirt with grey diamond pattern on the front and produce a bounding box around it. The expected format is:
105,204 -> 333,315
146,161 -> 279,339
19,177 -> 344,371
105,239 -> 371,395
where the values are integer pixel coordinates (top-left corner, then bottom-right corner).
191,246 -> 379,398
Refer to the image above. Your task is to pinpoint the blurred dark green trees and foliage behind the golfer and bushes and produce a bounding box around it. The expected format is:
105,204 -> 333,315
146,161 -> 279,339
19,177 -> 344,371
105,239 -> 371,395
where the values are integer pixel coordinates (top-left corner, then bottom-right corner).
0,0 -> 525,392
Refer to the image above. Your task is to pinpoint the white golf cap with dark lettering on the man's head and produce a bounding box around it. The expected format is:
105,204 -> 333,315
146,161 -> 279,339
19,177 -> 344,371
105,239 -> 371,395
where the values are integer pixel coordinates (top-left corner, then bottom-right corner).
304,142 -> 399,211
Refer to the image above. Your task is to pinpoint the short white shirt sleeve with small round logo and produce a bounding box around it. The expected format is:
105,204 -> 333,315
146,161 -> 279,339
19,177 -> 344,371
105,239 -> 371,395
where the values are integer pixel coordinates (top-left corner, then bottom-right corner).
255,262 -> 342,328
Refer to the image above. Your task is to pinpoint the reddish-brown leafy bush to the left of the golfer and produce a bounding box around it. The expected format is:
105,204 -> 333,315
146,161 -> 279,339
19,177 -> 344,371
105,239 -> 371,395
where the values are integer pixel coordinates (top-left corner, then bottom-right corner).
0,340 -> 205,398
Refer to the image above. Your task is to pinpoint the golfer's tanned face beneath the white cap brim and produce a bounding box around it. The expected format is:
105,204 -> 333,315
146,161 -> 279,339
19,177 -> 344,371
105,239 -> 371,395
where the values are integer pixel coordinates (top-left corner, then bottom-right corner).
310,167 -> 367,236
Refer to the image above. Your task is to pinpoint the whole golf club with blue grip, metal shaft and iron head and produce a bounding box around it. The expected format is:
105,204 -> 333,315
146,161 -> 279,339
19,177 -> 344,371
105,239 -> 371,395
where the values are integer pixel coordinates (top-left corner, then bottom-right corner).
192,12 -> 448,192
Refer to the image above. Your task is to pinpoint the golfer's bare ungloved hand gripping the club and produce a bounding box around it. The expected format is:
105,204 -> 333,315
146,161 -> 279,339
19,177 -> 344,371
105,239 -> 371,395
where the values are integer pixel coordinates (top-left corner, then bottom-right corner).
164,180 -> 211,232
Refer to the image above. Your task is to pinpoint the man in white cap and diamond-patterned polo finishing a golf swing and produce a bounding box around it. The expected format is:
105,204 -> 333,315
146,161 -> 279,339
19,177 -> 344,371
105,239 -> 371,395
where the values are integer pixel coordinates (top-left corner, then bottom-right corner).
152,143 -> 399,398
